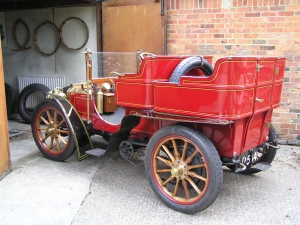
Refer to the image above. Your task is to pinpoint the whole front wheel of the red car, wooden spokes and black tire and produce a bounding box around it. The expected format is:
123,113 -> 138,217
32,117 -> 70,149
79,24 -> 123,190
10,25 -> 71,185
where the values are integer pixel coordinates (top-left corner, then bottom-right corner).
31,100 -> 75,161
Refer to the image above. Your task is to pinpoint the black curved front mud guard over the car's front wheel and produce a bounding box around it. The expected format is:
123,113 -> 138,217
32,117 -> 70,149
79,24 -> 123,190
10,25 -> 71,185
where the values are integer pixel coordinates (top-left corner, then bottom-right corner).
47,94 -> 94,161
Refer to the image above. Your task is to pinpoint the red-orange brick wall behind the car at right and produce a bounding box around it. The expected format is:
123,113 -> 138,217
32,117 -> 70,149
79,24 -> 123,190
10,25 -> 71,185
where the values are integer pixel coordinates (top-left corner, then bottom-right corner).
166,0 -> 300,139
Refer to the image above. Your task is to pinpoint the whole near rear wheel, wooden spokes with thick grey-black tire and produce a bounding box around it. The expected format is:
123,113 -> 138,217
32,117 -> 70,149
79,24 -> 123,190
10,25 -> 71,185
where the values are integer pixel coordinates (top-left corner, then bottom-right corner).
145,125 -> 223,213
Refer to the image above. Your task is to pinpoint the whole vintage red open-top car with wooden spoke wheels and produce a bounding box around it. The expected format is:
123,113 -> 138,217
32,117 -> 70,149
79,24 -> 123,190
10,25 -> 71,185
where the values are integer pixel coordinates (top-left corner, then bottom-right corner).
32,50 -> 286,213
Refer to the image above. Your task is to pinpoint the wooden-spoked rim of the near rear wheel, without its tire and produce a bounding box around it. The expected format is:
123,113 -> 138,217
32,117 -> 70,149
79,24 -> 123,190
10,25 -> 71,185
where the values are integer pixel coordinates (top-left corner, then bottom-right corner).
151,135 -> 209,205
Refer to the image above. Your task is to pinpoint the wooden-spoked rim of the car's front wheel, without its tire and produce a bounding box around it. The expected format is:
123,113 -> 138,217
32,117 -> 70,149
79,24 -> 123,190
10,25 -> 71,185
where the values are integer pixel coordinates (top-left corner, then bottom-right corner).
34,107 -> 70,155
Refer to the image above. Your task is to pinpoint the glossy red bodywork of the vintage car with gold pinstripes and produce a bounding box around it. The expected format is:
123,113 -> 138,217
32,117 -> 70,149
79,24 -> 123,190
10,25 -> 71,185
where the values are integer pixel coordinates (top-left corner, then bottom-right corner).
70,51 -> 285,158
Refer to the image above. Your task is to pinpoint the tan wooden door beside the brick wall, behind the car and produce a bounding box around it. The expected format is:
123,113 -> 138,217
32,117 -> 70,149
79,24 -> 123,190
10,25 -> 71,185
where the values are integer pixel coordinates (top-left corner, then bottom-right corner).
102,0 -> 166,54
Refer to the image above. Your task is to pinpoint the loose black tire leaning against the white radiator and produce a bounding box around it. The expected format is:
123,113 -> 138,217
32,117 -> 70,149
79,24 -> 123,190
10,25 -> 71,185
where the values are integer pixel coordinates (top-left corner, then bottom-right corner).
17,83 -> 50,123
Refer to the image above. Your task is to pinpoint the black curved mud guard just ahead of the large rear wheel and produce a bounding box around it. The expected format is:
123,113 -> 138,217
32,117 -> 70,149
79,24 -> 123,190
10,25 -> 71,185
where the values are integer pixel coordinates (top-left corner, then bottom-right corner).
106,115 -> 141,152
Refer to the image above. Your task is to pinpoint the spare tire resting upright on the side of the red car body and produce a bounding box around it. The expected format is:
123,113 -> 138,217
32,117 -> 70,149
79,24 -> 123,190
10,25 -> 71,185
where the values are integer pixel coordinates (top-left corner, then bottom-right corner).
169,57 -> 214,83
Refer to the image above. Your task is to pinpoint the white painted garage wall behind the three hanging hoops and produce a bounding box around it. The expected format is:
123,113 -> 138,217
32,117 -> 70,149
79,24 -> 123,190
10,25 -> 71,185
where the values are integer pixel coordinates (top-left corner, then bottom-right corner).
2,7 -> 97,90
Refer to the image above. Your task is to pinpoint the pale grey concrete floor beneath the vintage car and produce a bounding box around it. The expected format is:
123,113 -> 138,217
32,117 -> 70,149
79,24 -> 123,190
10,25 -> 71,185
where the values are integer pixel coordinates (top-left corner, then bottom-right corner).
0,116 -> 300,225
